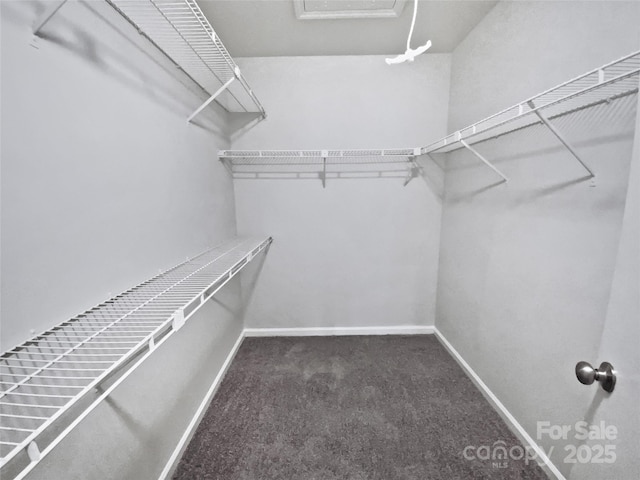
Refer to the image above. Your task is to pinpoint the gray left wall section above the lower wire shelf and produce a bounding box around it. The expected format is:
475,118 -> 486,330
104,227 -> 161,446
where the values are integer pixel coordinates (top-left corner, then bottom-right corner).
1,2 -> 235,350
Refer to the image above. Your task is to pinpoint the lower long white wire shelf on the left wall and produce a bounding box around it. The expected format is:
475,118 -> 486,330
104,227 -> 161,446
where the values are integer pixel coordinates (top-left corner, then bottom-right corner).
0,237 -> 272,478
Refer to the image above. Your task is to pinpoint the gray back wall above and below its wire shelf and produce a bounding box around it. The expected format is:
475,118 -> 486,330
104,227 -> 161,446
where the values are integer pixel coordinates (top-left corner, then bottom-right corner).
233,55 -> 449,327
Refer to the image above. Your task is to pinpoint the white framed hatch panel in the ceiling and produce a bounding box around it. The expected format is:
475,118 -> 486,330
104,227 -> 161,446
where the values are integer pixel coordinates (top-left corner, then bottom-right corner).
293,0 -> 406,20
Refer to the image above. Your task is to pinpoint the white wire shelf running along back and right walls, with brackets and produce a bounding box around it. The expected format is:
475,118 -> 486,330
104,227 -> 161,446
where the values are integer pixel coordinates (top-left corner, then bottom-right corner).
218,52 -> 640,185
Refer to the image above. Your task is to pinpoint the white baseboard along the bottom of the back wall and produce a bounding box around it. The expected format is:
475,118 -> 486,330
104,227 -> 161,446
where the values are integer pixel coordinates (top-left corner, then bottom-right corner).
244,325 -> 434,337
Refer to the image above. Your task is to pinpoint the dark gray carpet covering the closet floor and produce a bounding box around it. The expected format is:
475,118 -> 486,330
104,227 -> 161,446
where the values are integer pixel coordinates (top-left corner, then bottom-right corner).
174,335 -> 547,480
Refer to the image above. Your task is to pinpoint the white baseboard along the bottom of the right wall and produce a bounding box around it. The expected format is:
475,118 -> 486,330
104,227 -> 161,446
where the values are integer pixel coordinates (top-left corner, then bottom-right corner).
434,327 -> 566,480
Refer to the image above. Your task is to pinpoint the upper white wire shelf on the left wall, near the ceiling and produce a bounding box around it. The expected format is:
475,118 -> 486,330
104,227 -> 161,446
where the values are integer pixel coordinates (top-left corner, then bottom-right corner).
34,0 -> 266,121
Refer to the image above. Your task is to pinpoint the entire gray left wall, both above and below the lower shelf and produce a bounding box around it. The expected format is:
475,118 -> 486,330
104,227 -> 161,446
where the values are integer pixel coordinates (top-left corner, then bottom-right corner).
0,1 -> 242,480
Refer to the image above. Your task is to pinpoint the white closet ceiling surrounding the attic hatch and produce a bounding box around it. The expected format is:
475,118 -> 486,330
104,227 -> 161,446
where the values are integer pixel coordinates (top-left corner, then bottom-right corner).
198,0 -> 497,57
